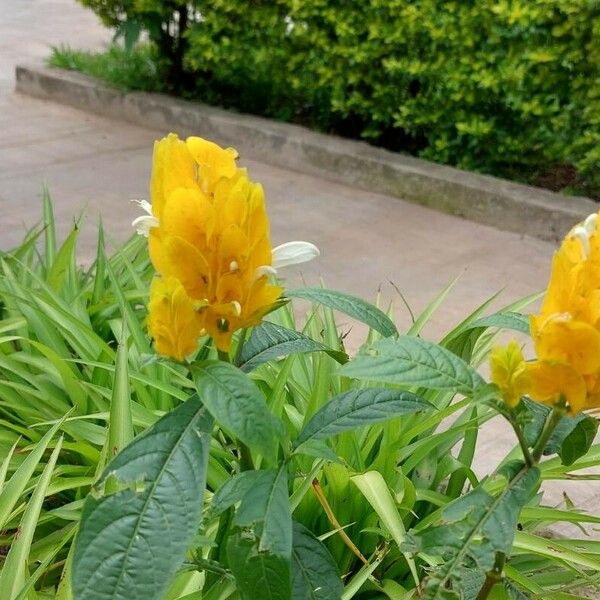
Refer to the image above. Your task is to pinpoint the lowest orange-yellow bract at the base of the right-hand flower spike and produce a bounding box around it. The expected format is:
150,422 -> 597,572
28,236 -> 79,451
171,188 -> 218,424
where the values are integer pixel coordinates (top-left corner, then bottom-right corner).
527,360 -> 587,414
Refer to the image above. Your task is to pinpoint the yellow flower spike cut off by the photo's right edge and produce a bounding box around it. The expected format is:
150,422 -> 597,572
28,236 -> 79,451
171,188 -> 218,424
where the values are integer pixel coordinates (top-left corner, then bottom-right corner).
491,214 -> 600,414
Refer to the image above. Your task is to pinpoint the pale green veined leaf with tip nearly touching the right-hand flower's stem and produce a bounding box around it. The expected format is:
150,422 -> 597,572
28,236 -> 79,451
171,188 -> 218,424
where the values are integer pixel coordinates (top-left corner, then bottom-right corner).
340,336 -> 484,395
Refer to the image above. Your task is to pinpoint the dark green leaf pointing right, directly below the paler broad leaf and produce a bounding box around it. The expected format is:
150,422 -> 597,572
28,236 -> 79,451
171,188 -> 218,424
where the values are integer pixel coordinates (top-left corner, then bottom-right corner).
294,388 -> 432,448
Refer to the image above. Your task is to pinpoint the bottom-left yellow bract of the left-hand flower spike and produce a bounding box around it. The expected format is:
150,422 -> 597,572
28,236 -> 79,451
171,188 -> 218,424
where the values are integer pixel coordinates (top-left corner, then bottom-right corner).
148,277 -> 204,361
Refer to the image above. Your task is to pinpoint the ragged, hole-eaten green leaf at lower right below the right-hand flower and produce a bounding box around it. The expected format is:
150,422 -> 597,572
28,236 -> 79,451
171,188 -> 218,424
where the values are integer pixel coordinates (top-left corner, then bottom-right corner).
404,463 -> 539,600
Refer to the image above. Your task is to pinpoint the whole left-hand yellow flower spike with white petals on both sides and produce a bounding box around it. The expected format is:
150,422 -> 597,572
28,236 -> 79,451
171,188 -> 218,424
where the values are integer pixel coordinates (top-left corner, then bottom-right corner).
133,134 -> 319,360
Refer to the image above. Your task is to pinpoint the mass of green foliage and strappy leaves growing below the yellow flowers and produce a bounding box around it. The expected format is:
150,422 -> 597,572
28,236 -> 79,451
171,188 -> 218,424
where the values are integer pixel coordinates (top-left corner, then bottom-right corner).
0,196 -> 600,600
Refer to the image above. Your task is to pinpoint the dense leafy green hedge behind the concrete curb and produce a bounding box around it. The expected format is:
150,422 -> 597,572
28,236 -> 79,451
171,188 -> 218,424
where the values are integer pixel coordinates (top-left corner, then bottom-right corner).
81,0 -> 600,194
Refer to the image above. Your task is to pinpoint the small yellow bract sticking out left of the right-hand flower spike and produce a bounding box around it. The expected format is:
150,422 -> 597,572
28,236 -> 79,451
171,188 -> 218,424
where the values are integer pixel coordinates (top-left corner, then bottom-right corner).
490,340 -> 529,407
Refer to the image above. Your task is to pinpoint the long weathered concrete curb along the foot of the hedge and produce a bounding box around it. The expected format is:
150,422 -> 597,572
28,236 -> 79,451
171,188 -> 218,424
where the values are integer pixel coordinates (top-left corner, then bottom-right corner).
16,66 -> 598,241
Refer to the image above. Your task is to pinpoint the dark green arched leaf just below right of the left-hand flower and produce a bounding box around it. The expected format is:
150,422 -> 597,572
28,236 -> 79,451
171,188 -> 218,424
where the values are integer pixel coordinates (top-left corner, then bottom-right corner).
236,321 -> 348,373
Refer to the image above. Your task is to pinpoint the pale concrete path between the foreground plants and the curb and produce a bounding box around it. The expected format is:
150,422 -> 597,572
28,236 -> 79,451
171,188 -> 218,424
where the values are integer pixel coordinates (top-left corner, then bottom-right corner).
0,0 -> 599,520
